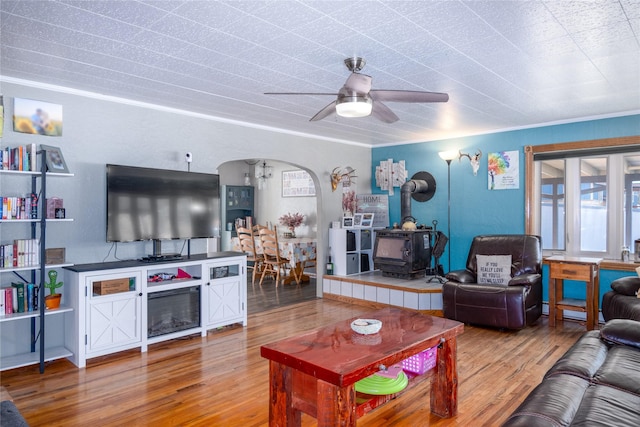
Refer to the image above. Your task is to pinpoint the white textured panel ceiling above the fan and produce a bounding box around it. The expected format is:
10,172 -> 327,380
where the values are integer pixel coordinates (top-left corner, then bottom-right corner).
0,0 -> 640,146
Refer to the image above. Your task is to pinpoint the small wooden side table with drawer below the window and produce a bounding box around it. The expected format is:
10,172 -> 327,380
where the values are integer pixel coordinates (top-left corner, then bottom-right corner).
545,256 -> 602,331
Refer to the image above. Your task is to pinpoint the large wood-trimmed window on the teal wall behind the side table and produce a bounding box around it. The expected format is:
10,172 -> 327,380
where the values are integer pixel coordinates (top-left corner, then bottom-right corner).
525,137 -> 640,259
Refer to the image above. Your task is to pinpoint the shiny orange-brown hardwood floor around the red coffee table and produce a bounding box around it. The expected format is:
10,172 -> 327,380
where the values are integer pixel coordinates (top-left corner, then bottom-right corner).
0,299 -> 584,427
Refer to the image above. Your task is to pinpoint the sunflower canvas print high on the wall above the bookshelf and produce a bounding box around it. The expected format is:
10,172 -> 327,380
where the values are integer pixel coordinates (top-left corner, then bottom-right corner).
13,98 -> 62,136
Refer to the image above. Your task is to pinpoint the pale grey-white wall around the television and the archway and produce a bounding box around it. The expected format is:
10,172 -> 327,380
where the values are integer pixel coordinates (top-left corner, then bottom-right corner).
0,82 -> 371,289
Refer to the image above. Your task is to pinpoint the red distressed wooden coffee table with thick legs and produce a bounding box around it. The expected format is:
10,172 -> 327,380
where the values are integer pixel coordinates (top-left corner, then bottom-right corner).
260,308 -> 464,427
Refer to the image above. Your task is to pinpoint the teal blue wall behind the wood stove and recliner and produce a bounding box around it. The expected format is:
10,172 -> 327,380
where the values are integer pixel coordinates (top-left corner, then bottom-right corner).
371,115 -> 640,300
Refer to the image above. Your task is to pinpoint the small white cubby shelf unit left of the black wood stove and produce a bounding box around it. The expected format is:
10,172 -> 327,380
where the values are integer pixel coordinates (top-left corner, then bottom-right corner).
329,227 -> 376,276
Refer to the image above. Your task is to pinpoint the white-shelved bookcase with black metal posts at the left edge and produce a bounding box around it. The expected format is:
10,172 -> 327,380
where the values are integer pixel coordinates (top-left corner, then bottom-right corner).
0,151 -> 73,373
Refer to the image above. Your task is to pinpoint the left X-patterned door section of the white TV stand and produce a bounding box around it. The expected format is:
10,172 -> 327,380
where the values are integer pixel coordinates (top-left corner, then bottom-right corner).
86,273 -> 142,357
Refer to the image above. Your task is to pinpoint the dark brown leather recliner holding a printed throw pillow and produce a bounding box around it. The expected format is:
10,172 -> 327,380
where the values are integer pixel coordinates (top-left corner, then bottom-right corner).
442,234 -> 542,329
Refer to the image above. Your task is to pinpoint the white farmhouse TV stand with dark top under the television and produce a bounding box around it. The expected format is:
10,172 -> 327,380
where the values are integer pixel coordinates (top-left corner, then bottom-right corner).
65,252 -> 247,368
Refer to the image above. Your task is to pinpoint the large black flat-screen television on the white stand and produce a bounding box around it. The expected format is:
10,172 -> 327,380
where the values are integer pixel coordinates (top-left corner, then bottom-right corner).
107,165 -> 220,242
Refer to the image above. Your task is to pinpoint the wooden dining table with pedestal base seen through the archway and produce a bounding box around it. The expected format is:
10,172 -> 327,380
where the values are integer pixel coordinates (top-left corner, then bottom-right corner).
231,237 -> 317,285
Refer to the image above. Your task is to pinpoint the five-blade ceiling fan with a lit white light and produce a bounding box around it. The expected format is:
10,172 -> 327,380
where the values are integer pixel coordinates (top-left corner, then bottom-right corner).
265,57 -> 449,123
